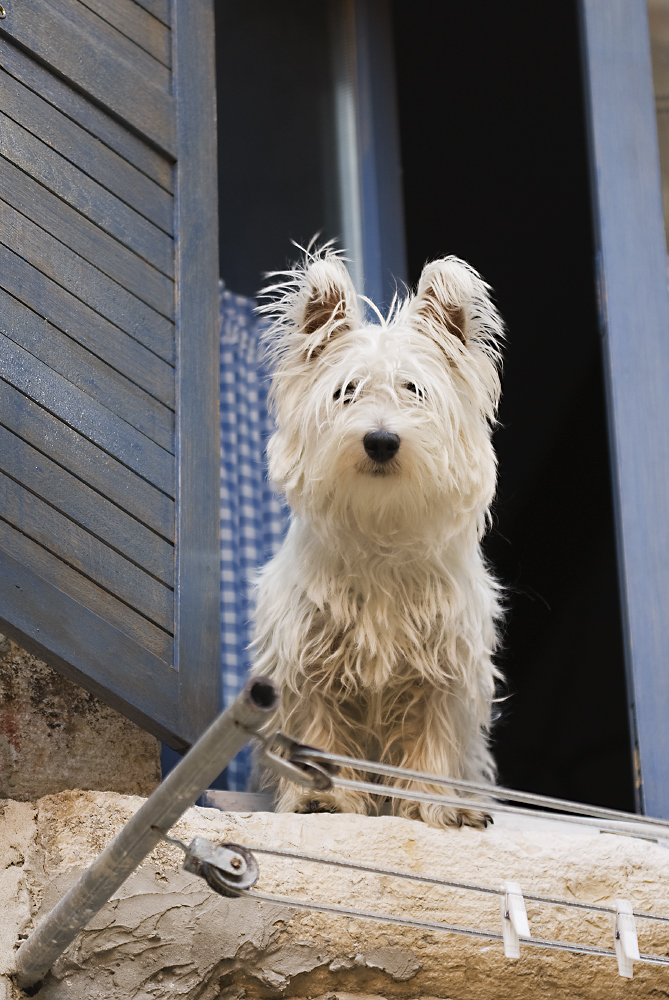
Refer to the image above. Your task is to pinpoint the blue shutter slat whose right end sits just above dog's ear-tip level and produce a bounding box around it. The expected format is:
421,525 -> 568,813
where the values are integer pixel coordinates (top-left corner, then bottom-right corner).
0,70 -> 174,235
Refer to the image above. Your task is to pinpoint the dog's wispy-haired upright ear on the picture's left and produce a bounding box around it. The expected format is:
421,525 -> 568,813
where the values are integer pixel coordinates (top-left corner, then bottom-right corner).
293,253 -> 360,357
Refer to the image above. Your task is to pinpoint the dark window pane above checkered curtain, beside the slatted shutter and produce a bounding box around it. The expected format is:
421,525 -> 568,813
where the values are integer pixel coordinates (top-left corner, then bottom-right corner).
215,0 -> 339,297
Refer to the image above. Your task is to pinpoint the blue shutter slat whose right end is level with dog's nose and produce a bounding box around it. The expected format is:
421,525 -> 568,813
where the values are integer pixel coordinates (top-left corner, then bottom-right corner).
0,289 -> 174,452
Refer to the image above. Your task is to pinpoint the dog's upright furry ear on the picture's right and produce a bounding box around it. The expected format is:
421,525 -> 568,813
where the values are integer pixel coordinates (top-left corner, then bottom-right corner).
410,257 -> 503,358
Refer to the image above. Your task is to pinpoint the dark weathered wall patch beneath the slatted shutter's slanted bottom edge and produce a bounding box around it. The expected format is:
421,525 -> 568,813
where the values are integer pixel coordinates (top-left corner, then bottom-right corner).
0,636 -> 160,800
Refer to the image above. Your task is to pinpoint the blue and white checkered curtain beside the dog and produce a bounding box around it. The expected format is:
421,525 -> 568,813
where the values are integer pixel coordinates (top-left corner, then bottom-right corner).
219,282 -> 288,790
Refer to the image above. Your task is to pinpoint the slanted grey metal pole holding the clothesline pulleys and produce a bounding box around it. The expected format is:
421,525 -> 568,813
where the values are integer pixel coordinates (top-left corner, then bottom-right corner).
15,677 -> 279,988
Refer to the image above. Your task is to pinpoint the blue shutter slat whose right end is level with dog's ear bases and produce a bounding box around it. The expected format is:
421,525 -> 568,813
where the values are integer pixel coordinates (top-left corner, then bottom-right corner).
0,200 -> 175,352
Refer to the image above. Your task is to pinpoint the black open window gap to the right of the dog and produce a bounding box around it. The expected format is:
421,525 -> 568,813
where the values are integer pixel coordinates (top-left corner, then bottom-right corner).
393,0 -> 634,809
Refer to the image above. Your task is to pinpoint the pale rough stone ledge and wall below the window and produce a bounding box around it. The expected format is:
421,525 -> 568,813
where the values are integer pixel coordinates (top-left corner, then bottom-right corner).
0,792 -> 669,1000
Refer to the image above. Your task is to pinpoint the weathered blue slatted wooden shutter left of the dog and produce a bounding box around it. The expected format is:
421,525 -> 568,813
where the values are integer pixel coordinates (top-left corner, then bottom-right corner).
0,0 -> 219,749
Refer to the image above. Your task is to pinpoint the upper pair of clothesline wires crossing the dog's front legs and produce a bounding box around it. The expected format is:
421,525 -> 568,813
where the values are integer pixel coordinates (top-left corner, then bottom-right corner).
308,747 -> 669,836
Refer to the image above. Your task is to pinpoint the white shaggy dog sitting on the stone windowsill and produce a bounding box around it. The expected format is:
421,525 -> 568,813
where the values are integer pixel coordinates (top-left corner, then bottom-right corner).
255,247 -> 502,826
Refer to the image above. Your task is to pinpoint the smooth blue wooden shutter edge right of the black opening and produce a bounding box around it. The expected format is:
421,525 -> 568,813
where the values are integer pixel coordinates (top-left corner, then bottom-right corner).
580,0 -> 669,818
